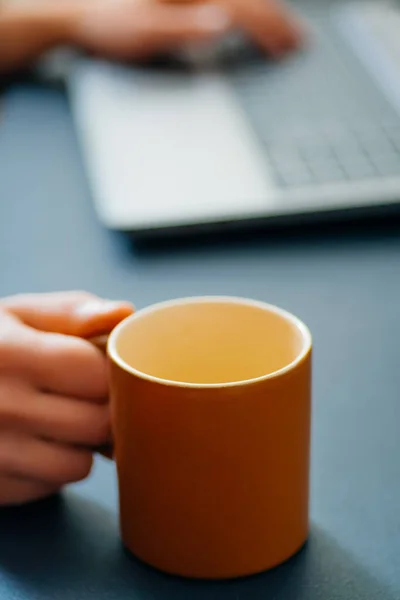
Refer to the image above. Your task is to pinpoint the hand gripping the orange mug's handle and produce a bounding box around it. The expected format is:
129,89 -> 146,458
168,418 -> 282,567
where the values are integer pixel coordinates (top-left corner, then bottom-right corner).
0,292 -> 132,505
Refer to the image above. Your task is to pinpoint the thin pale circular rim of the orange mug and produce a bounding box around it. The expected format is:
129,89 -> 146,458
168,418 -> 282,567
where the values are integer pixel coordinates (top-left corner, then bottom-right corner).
107,296 -> 312,389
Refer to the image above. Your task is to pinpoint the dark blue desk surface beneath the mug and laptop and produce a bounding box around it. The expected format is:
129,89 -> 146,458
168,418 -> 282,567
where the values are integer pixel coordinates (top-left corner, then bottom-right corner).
0,81 -> 400,600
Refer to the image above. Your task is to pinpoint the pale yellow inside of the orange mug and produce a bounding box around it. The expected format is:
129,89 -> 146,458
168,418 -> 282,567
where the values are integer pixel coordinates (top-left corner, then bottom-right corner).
109,299 -> 311,385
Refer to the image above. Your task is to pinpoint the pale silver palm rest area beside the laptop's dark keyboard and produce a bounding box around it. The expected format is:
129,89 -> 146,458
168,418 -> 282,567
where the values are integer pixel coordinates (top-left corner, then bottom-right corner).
71,61 -> 275,228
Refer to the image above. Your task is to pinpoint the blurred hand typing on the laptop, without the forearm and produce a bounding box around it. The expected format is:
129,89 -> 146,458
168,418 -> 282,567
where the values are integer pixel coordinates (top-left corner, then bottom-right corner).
72,0 -> 302,60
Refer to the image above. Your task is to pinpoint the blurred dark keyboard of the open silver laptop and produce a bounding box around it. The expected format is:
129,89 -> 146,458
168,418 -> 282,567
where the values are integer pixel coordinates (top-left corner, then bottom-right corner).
228,7 -> 400,188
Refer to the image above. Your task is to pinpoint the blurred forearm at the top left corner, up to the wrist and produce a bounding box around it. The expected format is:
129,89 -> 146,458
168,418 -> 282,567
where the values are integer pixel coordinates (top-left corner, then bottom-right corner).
0,0 -> 81,73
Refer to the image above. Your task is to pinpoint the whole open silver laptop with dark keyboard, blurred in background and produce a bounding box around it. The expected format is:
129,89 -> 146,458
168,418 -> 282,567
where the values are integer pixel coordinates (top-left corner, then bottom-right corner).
68,0 -> 400,235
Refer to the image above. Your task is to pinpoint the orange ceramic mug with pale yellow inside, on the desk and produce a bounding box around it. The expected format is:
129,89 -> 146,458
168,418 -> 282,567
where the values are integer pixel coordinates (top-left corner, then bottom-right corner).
104,297 -> 311,578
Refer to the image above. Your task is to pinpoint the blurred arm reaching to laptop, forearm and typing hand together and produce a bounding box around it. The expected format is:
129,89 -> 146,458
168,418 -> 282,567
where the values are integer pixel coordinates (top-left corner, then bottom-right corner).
0,0 -> 303,72
